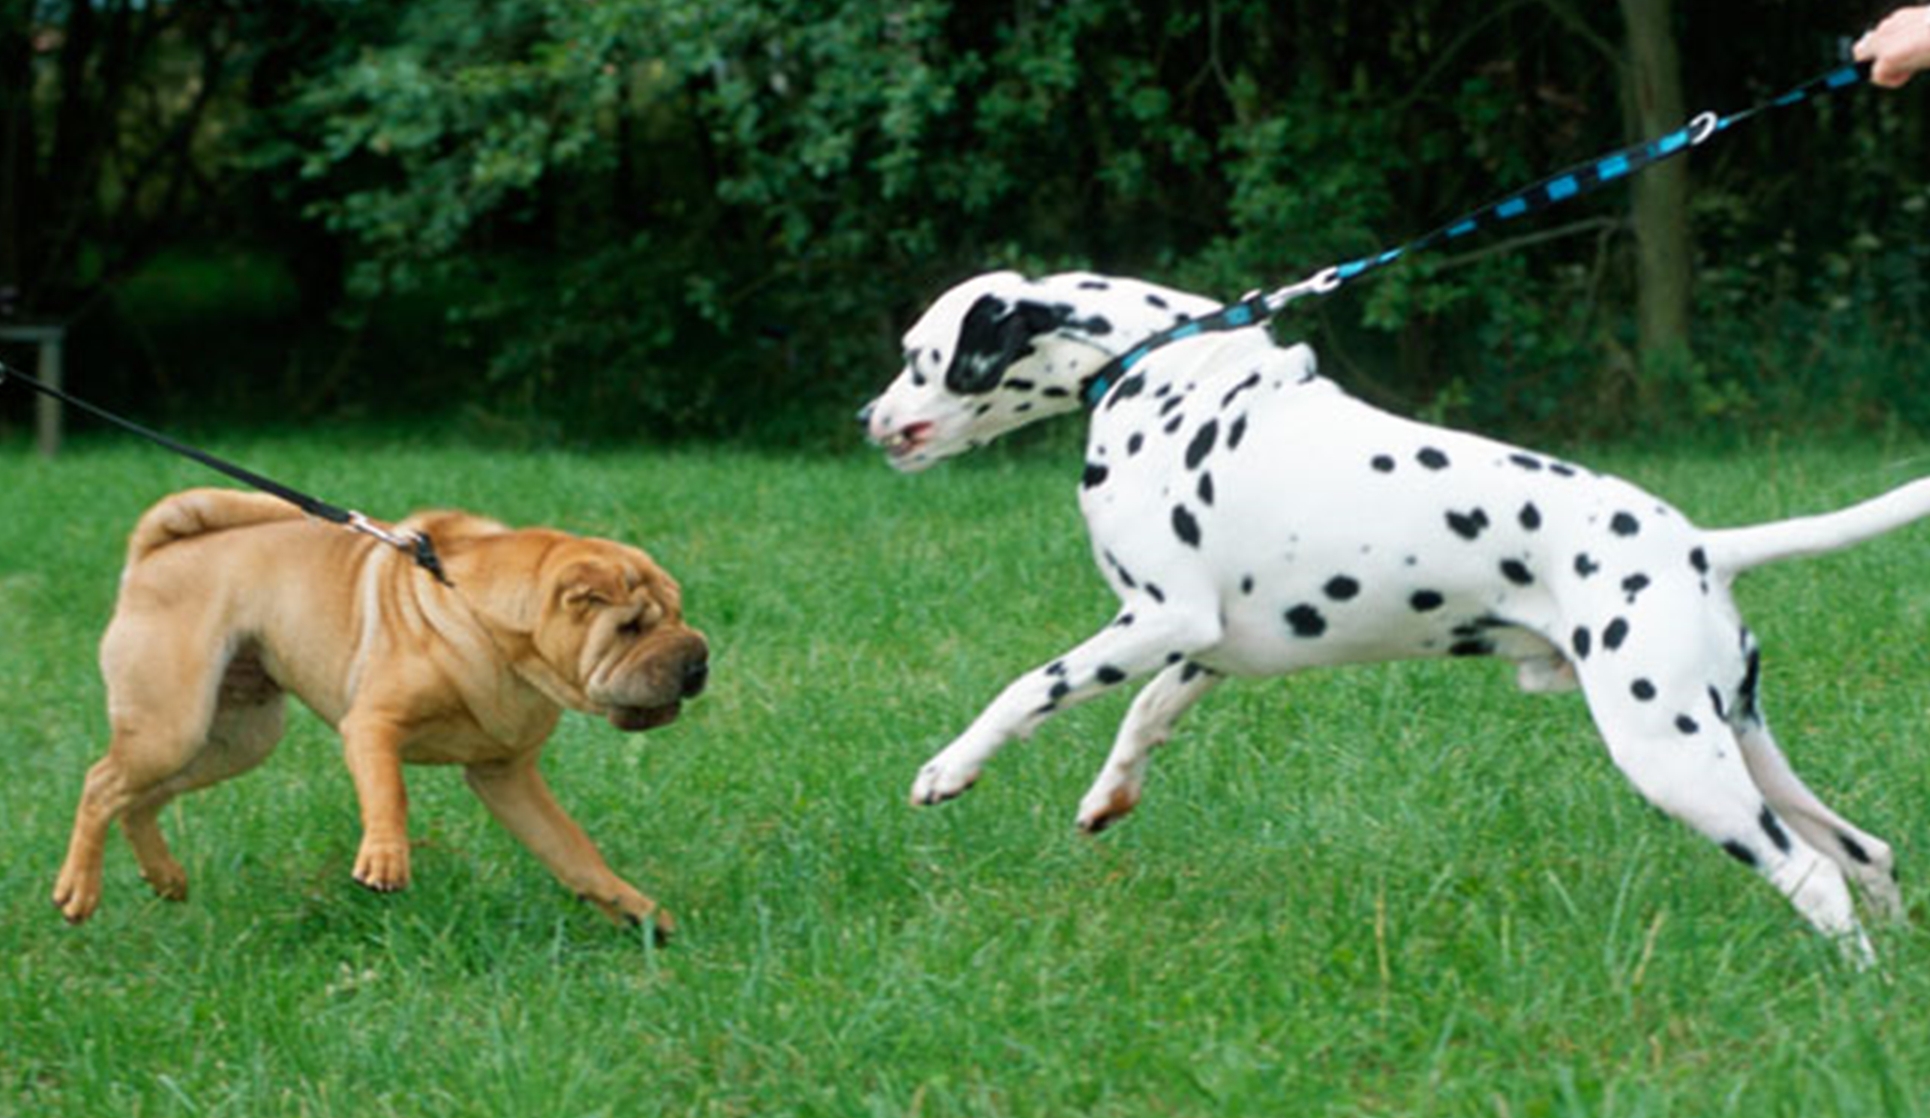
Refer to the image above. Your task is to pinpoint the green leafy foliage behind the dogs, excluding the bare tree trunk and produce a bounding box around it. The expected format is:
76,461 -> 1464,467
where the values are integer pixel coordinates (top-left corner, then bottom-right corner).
0,0 -> 1930,440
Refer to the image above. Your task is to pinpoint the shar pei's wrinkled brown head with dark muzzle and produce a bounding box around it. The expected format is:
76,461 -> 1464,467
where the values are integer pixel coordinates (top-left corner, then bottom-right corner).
533,537 -> 710,730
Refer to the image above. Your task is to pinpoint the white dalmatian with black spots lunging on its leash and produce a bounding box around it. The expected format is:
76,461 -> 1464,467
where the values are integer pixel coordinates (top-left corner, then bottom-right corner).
861,272 -> 1930,960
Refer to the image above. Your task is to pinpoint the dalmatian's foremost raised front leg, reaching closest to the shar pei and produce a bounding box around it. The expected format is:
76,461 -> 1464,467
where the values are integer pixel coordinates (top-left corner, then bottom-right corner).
911,606 -> 1220,805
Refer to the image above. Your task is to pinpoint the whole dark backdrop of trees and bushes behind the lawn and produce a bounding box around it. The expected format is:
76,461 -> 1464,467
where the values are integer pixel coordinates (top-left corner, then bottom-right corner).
0,0 -> 1930,448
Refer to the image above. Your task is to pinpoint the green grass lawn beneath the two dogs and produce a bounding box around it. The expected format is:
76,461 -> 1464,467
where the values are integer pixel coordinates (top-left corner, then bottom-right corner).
0,431 -> 1930,1118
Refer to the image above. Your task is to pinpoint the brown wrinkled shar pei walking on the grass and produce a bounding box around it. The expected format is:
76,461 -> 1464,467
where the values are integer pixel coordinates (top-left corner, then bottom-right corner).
54,489 -> 708,935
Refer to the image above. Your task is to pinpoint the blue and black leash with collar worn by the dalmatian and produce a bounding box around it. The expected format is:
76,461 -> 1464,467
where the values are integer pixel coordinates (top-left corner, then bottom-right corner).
1083,62 -> 1870,407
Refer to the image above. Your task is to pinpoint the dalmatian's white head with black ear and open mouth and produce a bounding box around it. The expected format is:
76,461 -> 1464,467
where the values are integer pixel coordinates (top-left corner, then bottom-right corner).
859,272 -> 1117,473
